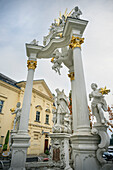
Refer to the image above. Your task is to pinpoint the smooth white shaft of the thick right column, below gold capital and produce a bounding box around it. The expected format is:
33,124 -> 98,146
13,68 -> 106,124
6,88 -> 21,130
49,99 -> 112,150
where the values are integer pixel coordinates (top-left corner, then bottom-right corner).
73,47 -> 90,131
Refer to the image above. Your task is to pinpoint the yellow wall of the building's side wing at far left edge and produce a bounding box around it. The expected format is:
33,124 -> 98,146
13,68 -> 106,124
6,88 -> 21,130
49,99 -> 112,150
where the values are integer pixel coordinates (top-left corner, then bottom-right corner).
0,81 -> 20,145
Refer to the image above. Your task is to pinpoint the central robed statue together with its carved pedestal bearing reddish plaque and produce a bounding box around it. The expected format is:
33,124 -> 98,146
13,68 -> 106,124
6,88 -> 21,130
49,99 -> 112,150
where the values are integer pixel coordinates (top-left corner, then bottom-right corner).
50,89 -> 72,170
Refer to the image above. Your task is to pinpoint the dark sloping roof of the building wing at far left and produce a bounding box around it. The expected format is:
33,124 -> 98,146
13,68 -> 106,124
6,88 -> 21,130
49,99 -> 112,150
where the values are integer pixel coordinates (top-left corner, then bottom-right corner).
0,73 -> 20,89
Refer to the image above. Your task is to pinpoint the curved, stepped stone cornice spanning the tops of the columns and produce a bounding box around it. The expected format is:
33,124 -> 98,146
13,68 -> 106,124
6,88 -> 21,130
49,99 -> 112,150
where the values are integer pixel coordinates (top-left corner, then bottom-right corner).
26,17 -> 88,59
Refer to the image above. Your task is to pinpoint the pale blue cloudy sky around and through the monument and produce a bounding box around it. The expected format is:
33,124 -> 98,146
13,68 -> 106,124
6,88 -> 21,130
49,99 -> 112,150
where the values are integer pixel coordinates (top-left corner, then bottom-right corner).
0,0 -> 113,104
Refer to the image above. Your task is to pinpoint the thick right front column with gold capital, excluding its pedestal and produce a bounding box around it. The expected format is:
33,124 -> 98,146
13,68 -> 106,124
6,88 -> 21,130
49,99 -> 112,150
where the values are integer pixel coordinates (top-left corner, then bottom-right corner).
69,36 -> 90,132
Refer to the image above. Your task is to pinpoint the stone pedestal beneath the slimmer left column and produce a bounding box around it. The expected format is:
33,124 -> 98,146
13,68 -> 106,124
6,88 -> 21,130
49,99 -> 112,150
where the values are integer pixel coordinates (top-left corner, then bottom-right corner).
9,133 -> 30,170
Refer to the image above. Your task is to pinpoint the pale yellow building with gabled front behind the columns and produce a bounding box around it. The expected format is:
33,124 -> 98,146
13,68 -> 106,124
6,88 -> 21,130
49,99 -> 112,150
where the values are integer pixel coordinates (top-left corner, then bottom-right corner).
0,74 -> 54,154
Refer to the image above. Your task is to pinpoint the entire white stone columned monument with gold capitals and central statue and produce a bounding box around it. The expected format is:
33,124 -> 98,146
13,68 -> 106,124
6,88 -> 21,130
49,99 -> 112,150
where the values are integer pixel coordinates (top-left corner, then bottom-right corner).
11,7 -> 112,170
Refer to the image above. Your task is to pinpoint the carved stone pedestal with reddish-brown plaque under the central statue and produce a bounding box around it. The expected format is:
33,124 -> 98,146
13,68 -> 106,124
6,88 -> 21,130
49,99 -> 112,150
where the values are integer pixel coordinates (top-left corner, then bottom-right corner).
50,133 -> 72,170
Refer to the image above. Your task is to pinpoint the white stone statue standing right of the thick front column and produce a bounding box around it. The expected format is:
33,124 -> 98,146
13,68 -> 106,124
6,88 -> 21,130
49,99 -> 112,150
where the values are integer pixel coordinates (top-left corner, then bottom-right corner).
89,83 -> 107,124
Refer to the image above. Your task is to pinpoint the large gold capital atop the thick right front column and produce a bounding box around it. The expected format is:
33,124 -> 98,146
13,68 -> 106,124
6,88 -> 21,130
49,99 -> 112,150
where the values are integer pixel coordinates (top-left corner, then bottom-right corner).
69,36 -> 84,49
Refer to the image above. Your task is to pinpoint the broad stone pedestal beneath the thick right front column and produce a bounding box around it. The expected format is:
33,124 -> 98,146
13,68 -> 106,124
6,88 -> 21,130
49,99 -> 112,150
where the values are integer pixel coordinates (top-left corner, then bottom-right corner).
71,132 -> 101,170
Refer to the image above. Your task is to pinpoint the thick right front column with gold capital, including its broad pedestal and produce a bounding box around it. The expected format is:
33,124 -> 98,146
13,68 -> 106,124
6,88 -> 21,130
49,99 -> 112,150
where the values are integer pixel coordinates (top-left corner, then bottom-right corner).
69,36 -> 100,170
